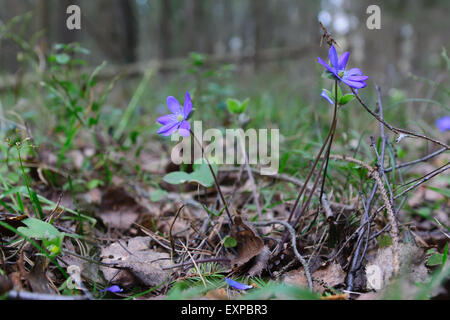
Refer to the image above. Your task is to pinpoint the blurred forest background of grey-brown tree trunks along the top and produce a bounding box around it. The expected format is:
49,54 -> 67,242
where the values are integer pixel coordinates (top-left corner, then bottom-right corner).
0,0 -> 450,84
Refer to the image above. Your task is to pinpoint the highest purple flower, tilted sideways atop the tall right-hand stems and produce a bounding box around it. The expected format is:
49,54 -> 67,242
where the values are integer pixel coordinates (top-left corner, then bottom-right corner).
317,46 -> 369,89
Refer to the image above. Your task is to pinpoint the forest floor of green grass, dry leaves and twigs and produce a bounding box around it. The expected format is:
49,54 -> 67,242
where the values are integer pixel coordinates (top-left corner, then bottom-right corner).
0,38 -> 450,299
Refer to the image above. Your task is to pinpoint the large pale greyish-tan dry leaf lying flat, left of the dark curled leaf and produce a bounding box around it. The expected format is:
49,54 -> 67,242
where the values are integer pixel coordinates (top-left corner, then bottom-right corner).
100,237 -> 170,287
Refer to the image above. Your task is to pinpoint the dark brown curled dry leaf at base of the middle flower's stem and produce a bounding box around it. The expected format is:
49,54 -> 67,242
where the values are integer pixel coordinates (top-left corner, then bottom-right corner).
231,216 -> 264,267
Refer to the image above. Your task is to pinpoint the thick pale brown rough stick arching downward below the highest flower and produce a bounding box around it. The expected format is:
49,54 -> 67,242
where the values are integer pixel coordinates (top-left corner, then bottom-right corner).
330,155 -> 400,274
